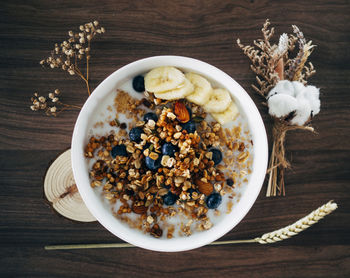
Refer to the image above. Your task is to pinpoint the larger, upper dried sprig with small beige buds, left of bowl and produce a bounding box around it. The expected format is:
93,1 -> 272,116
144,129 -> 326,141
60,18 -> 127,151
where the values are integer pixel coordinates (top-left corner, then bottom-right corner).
40,20 -> 106,95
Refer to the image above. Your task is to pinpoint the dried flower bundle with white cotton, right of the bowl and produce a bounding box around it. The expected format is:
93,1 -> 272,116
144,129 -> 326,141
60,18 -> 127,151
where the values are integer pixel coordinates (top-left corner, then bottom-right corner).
237,19 -> 320,196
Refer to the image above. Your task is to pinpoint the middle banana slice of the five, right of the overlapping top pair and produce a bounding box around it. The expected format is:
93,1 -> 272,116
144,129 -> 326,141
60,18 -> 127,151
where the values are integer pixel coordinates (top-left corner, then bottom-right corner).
185,72 -> 213,106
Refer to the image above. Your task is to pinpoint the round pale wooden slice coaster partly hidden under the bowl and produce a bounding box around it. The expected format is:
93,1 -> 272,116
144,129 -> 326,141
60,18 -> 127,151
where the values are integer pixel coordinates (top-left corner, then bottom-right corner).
44,150 -> 96,222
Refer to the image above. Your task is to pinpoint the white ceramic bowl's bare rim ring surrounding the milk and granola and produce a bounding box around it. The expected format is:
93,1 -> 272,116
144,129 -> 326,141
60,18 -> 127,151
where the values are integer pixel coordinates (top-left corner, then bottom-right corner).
72,56 -> 268,252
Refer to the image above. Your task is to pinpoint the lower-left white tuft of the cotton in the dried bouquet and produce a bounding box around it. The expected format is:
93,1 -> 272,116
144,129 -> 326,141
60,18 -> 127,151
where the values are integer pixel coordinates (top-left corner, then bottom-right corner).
267,94 -> 298,118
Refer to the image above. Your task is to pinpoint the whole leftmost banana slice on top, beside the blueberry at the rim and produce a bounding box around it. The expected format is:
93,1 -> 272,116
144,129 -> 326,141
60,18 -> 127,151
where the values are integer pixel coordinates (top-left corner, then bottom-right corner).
145,67 -> 185,93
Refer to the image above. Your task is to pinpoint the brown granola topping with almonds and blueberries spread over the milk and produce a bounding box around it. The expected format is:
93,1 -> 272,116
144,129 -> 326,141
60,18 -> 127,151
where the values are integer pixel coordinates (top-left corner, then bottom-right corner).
85,72 -> 252,238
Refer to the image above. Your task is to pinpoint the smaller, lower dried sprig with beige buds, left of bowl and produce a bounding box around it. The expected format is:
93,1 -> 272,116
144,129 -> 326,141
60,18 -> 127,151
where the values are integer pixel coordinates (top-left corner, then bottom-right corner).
30,89 -> 81,117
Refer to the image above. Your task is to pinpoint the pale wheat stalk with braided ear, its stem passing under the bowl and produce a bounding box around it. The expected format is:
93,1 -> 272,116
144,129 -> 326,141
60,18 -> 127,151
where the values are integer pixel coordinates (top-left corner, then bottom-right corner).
45,201 -> 338,250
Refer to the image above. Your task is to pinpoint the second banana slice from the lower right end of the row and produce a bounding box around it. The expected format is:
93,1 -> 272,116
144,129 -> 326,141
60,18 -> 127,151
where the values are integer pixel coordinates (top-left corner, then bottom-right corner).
203,88 -> 231,113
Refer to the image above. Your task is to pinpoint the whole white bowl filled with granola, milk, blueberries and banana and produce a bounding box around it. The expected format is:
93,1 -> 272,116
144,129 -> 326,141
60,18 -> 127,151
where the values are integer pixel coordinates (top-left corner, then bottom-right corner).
72,56 -> 268,252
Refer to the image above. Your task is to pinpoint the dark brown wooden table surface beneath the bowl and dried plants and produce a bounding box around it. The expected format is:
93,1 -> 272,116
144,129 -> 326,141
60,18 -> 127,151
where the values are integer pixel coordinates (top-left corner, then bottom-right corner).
0,0 -> 350,277
